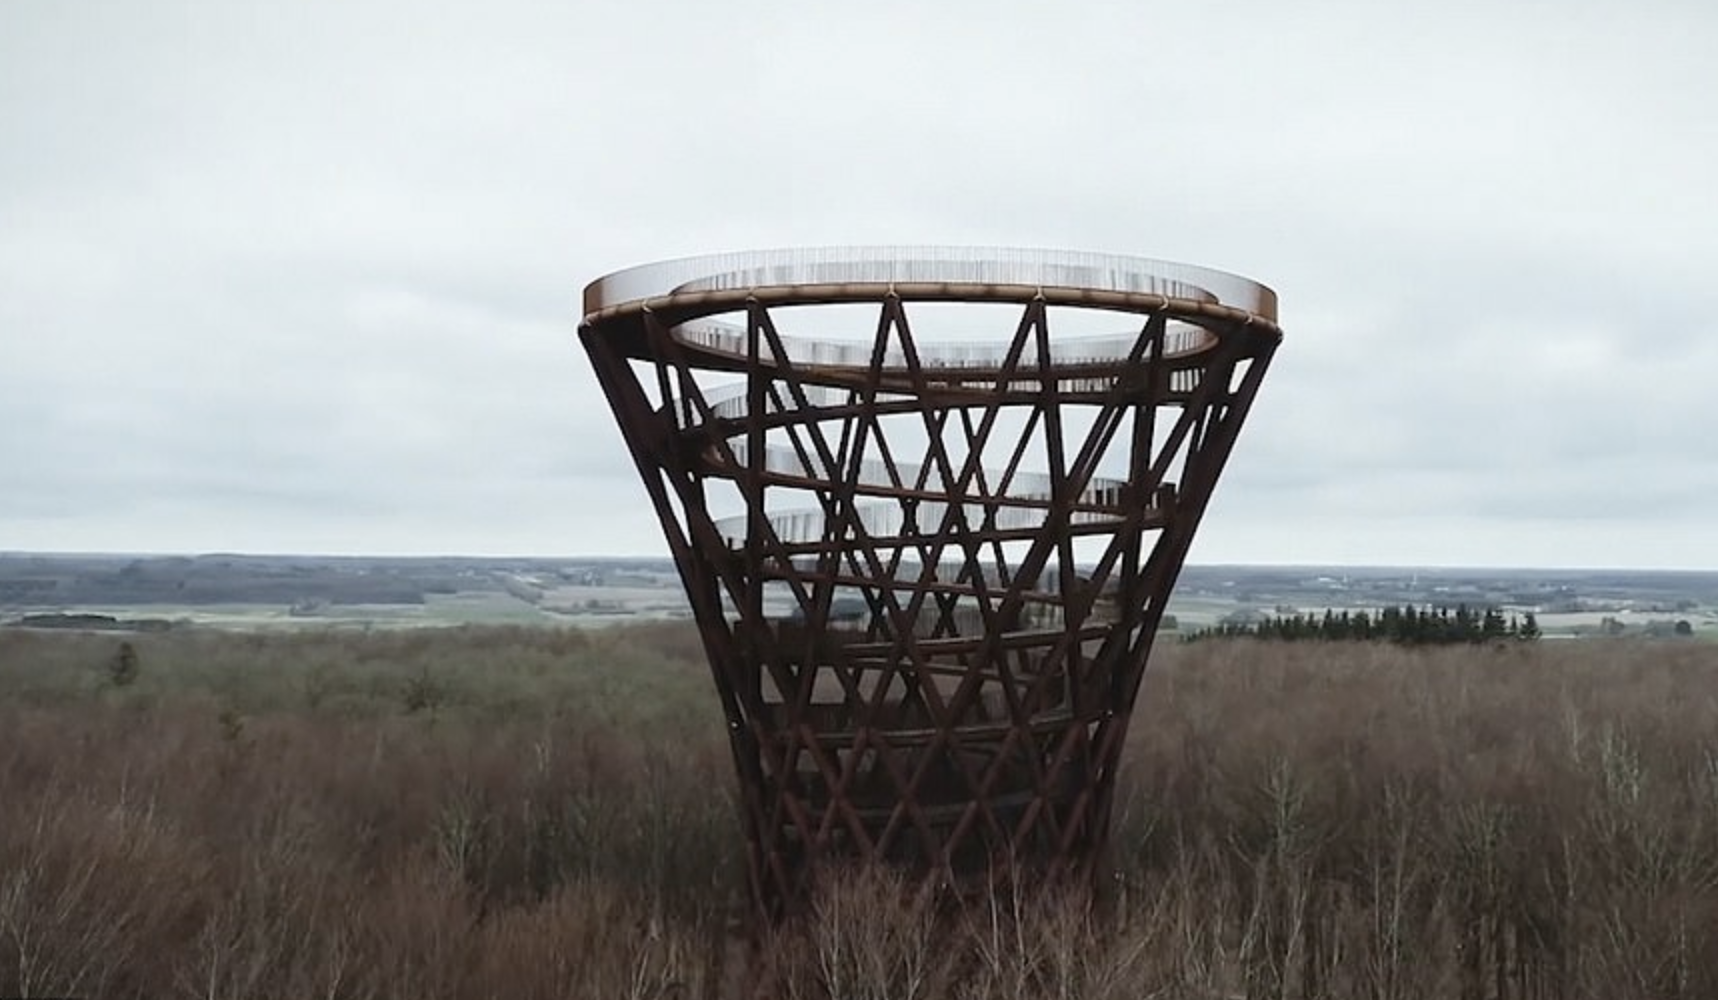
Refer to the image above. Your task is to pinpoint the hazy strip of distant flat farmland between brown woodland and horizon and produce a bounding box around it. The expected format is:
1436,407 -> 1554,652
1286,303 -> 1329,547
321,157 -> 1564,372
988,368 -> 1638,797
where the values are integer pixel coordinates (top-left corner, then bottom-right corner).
0,553 -> 1718,639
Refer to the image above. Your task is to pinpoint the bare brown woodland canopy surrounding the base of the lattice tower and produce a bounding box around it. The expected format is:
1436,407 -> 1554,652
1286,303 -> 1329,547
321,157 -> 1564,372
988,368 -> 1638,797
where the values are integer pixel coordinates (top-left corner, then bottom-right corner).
0,625 -> 1718,1000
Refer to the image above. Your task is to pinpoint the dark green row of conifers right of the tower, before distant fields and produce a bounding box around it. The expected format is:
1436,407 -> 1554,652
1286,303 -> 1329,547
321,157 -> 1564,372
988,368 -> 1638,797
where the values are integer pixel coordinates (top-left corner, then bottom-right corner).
1187,605 -> 1541,646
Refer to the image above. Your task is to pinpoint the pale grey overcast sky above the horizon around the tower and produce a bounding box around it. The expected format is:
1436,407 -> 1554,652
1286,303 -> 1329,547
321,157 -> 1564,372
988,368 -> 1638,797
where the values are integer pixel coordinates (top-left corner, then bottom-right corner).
0,0 -> 1718,569
